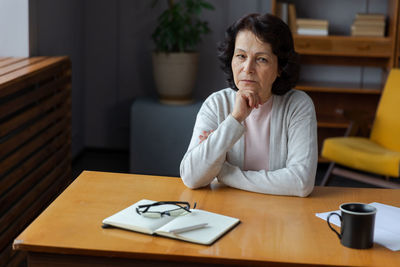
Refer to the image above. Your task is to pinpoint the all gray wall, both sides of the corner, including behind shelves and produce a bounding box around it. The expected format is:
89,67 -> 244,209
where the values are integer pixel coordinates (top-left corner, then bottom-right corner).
30,0 -> 386,155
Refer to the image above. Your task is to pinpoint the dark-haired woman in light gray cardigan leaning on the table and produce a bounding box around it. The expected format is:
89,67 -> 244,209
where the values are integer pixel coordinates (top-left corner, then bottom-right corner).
180,14 -> 318,197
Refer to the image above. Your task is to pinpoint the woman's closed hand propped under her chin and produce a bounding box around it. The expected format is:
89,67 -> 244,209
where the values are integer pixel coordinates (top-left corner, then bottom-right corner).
232,89 -> 261,123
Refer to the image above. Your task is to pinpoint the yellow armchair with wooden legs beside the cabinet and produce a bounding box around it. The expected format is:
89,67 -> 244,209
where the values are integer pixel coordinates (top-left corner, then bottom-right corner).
321,69 -> 400,188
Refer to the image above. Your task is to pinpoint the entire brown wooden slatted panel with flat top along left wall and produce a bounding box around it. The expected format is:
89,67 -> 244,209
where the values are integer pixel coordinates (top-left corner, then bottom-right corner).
0,57 -> 71,266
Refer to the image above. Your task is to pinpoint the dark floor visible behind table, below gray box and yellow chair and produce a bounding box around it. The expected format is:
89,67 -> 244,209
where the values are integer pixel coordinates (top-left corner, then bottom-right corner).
72,149 -> 392,187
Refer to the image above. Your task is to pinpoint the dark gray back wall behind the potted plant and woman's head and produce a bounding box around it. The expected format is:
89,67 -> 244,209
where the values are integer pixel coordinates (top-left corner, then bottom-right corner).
80,0 -> 272,151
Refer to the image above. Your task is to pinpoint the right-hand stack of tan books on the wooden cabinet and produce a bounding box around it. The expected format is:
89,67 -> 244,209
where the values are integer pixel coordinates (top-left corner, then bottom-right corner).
351,13 -> 386,37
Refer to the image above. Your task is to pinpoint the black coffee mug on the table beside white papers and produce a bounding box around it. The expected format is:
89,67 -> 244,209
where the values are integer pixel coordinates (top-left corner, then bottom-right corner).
326,203 -> 376,249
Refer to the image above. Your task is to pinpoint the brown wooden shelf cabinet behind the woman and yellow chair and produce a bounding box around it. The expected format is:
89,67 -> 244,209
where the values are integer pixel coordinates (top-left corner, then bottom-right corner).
271,0 -> 400,162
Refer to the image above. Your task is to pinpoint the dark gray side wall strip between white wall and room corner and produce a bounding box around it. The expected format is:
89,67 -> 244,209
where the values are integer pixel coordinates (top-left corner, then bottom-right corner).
29,0 -> 85,156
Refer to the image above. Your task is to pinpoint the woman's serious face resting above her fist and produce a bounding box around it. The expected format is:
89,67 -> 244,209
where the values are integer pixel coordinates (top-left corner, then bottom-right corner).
231,30 -> 278,103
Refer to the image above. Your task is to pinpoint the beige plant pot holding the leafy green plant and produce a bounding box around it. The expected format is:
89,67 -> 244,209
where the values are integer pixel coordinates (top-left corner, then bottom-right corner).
153,53 -> 198,104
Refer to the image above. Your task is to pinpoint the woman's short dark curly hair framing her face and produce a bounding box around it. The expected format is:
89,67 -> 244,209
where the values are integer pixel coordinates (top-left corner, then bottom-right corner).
218,13 -> 300,95
